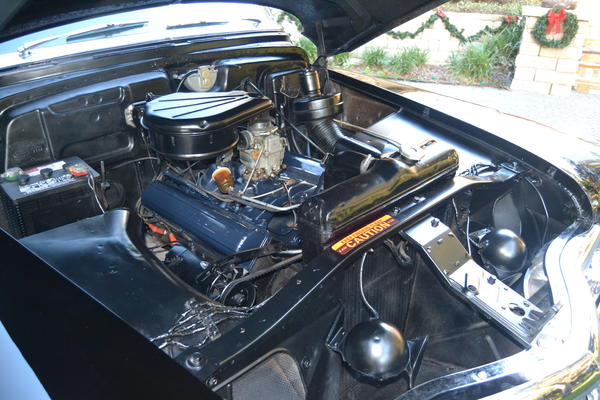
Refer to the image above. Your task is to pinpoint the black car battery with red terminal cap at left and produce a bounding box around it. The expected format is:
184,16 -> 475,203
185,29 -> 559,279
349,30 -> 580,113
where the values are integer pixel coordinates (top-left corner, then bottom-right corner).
0,157 -> 101,238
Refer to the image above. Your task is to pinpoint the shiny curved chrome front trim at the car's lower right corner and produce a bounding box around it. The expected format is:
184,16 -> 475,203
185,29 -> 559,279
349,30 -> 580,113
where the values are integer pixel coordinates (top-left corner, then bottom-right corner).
398,220 -> 600,400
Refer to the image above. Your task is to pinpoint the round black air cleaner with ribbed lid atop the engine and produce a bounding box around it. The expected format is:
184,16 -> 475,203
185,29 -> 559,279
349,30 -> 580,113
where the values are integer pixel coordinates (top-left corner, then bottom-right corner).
142,90 -> 273,160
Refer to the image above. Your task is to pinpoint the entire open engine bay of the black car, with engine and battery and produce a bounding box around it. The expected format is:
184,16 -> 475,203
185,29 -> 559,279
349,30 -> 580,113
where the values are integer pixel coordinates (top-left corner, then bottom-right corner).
0,51 -> 581,399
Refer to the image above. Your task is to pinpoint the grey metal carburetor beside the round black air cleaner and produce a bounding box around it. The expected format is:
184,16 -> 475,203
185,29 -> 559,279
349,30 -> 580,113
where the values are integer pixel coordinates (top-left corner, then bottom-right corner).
238,120 -> 287,180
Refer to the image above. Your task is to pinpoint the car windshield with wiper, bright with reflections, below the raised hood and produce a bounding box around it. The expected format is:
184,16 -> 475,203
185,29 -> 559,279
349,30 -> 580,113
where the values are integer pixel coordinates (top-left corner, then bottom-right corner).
0,3 -> 278,59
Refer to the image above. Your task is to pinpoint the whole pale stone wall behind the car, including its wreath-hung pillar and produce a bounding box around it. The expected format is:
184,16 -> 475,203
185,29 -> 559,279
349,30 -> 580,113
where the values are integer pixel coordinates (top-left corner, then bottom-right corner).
285,5 -> 600,95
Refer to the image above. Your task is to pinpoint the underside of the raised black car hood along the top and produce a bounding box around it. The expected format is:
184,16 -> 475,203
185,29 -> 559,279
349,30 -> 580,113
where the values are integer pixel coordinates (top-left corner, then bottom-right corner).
0,0 -> 447,55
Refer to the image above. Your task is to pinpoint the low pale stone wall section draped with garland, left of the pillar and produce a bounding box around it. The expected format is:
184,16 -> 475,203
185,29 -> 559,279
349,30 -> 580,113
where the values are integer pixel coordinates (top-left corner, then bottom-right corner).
355,11 -> 504,65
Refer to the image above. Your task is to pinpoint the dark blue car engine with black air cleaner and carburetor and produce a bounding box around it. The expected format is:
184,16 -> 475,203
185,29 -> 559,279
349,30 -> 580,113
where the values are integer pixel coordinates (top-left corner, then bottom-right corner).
136,69 -> 458,307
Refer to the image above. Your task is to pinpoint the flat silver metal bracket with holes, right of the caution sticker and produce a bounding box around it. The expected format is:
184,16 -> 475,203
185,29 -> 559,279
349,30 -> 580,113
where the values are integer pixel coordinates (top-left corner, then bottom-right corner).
404,217 -> 551,347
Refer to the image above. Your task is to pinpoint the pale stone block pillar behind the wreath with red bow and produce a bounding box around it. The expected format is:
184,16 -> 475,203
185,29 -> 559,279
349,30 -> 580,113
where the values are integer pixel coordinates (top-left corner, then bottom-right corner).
510,6 -> 589,96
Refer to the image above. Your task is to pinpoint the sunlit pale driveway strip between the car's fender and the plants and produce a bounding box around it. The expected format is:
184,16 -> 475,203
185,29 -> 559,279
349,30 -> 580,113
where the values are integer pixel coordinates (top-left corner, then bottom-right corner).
401,81 -> 600,144
